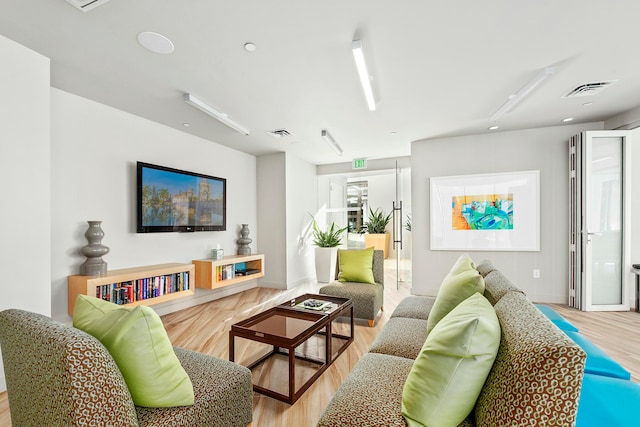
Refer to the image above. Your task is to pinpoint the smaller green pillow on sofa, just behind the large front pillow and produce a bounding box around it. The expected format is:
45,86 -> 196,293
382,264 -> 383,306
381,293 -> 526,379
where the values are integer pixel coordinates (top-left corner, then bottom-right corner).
427,270 -> 484,332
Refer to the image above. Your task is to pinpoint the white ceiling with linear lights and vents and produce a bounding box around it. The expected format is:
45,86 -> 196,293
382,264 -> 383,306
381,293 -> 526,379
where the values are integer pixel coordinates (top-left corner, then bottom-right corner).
0,0 -> 640,164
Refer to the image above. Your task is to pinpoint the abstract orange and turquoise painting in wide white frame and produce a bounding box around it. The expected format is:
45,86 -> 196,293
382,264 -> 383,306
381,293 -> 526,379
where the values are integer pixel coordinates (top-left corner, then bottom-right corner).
430,171 -> 540,251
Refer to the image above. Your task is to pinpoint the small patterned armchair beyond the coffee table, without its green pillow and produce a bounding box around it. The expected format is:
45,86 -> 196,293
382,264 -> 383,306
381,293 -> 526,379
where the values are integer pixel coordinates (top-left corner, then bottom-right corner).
319,250 -> 384,326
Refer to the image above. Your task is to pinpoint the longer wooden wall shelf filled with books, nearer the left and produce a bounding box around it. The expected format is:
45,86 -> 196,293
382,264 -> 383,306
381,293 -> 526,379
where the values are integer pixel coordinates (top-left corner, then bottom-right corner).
67,263 -> 195,316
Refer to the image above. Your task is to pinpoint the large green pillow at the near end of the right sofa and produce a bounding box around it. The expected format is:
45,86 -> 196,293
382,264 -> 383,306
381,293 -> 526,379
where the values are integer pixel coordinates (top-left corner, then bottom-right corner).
402,293 -> 500,427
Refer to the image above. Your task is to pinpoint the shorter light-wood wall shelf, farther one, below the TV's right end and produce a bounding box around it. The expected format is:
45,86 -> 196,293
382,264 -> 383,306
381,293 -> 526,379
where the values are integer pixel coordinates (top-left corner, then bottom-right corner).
192,254 -> 264,289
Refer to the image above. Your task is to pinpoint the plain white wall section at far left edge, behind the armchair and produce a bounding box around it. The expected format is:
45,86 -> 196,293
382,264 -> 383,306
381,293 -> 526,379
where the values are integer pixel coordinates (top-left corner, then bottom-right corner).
0,36 -> 51,391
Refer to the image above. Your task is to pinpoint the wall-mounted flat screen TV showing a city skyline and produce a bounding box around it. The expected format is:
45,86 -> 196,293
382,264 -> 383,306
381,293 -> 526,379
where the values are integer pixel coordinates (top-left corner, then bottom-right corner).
137,162 -> 227,233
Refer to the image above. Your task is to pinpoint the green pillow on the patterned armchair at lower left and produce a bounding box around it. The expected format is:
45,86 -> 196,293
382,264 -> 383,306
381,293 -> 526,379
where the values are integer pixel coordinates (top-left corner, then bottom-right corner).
73,295 -> 194,408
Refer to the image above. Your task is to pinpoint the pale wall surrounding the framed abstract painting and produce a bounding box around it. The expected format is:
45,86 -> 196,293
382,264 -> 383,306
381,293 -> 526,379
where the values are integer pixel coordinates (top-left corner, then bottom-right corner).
411,122 -> 603,303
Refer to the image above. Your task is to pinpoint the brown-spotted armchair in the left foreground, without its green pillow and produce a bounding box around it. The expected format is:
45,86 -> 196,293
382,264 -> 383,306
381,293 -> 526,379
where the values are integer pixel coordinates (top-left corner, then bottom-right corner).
0,309 -> 252,427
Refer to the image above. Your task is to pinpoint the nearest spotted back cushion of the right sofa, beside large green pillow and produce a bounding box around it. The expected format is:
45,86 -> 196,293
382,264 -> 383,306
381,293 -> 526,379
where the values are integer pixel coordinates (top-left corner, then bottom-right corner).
475,292 -> 586,427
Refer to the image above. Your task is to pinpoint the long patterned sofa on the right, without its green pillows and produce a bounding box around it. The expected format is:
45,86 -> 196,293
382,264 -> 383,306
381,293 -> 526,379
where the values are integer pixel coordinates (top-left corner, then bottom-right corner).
318,261 -> 586,427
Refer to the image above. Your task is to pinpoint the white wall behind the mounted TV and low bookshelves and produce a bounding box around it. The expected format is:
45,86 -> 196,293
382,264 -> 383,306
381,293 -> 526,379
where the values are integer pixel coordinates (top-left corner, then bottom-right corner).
50,89 -> 258,321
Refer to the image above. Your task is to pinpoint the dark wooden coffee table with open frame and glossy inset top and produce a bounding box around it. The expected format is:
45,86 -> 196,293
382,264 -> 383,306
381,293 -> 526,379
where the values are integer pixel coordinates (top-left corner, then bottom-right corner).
229,294 -> 354,404
